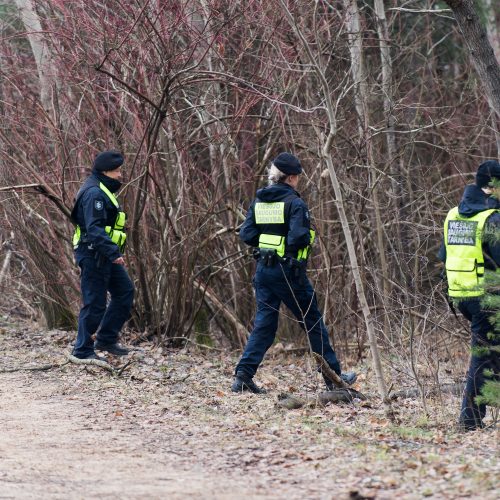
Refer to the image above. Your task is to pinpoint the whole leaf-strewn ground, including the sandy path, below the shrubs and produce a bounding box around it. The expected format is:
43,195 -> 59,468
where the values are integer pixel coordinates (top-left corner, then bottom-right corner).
0,321 -> 500,500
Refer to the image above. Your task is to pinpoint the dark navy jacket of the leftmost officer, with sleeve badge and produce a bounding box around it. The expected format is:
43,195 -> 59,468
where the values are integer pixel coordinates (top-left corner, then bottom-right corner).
71,173 -> 122,262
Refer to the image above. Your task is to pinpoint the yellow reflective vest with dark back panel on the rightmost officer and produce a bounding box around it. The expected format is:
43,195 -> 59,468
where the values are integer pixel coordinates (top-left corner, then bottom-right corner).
444,207 -> 498,297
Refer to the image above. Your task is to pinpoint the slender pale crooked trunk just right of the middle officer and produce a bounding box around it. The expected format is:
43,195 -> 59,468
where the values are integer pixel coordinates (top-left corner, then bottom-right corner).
279,0 -> 394,420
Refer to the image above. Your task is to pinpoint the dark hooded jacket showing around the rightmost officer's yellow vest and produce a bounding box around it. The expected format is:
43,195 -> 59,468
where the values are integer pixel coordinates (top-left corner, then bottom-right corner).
438,184 -> 500,270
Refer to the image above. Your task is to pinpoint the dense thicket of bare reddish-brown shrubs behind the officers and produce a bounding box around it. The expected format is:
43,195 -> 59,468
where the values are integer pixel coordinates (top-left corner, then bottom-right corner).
0,0 -> 497,368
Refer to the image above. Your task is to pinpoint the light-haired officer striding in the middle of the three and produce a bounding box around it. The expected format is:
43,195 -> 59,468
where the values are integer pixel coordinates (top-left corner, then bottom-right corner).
231,153 -> 356,393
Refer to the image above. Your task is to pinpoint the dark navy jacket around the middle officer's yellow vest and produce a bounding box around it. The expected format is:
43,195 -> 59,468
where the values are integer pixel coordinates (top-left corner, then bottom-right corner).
240,183 -> 311,256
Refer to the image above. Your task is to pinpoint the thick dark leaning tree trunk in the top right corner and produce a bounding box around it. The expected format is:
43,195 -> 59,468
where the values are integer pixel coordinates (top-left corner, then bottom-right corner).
445,0 -> 500,119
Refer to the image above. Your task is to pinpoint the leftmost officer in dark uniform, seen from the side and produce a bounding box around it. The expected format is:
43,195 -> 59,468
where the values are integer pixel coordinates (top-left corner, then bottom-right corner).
71,151 -> 134,359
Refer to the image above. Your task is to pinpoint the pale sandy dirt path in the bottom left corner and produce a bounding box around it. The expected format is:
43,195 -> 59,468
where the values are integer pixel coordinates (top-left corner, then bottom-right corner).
0,374 -> 262,499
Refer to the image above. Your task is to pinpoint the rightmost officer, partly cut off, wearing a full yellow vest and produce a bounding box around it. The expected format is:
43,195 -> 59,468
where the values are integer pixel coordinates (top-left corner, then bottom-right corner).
440,160 -> 500,430
